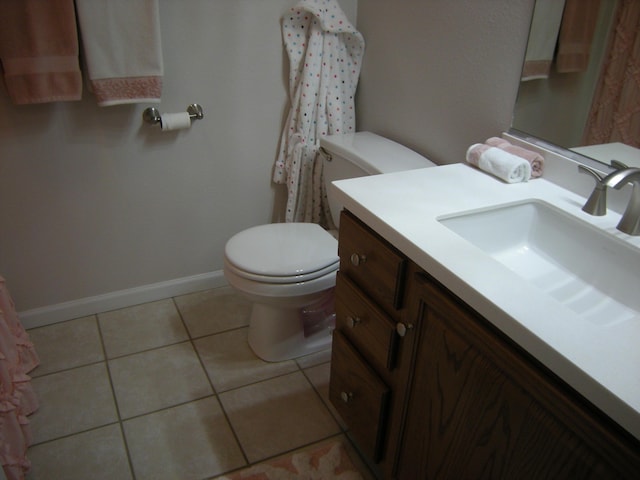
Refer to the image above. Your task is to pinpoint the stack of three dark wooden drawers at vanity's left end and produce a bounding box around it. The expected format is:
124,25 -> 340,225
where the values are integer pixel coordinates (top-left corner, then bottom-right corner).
329,212 -> 415,477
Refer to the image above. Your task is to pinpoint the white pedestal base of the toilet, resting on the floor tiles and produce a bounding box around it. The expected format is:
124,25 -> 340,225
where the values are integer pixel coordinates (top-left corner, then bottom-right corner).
249,303 -> 332,362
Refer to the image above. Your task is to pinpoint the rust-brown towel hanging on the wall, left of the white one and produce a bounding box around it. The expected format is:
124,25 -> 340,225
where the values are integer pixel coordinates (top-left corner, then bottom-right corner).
0,0 -> 82,105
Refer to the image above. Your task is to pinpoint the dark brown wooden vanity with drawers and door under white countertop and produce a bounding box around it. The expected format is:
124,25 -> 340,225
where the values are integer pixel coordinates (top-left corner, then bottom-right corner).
329,211 -> 640,480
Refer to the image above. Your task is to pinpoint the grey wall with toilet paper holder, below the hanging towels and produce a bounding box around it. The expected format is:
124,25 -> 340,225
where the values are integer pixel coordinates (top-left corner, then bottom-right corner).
0,0 -> 357,325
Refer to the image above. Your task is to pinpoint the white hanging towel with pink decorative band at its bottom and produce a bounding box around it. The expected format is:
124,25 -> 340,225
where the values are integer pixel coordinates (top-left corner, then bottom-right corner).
76,0 -> 163,106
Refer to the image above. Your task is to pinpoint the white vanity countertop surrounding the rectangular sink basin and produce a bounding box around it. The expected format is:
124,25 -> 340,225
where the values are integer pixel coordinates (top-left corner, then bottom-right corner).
331,163 -> 640,439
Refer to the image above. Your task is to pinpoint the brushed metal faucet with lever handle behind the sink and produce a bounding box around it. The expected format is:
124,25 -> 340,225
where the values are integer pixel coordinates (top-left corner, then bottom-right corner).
578,161 -> 640,235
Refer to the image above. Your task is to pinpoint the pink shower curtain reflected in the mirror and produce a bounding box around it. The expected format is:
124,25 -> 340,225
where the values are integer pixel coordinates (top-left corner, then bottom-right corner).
583,0 -> 640,148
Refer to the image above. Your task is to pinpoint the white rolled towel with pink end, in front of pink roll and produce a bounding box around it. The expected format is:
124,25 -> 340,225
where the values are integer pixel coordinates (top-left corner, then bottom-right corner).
467,143 -> 531,183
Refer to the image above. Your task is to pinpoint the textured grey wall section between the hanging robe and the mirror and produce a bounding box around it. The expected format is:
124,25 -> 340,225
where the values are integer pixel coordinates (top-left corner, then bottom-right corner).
356,0 -> 534,163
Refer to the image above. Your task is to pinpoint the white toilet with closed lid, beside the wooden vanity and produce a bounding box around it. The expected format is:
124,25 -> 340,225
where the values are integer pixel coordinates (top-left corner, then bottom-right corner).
224,132 -> 435,362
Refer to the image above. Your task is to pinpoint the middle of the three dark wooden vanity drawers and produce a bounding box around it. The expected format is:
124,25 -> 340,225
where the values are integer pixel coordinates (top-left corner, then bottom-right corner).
336,272 -> 398,370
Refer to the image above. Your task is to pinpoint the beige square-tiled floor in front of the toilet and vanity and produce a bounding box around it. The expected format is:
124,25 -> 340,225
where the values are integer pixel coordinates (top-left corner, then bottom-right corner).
27,287 -> 368,480
